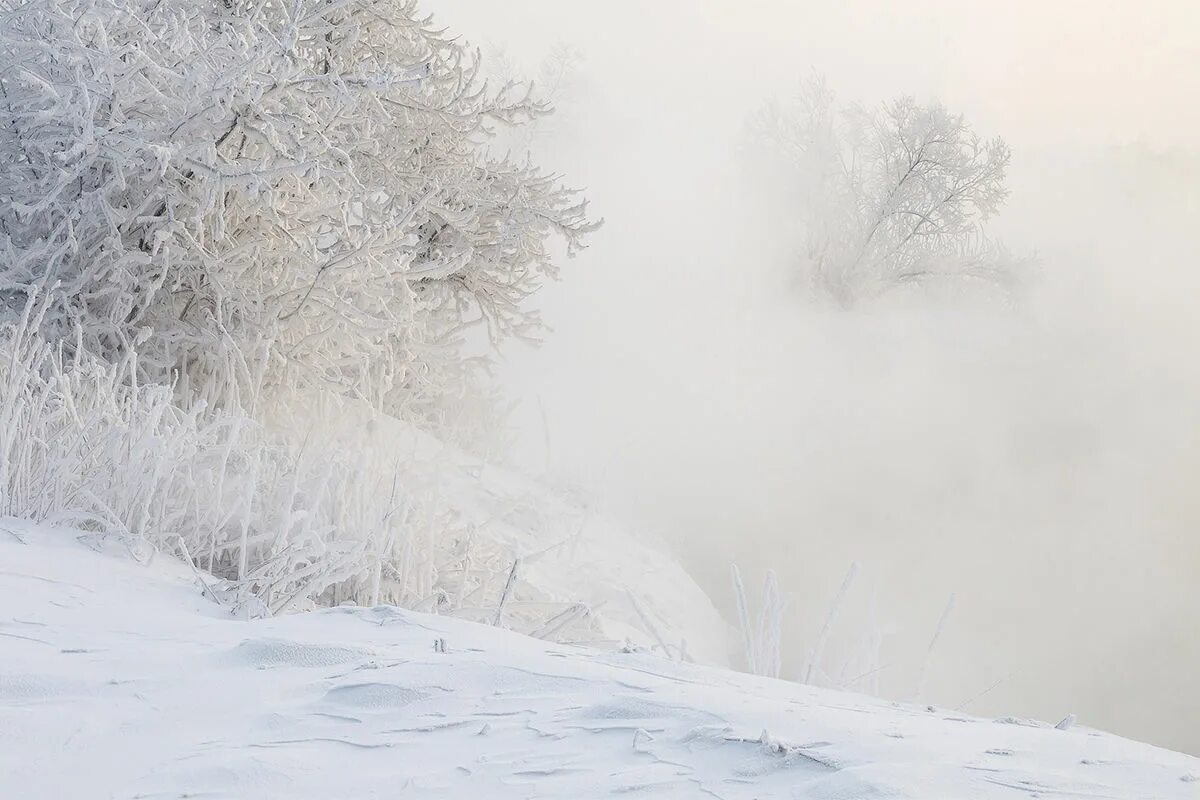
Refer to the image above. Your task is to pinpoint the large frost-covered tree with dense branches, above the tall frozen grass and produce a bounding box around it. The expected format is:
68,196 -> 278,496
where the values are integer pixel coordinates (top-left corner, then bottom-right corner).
0,0 -> 594,438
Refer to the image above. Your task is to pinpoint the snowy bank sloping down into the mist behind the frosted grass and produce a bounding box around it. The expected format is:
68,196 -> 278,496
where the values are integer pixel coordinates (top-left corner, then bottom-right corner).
298,401 -> 738,667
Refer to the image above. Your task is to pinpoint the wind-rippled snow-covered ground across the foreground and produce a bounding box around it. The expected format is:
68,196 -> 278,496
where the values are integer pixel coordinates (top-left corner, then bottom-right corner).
0,522 -> 1200,800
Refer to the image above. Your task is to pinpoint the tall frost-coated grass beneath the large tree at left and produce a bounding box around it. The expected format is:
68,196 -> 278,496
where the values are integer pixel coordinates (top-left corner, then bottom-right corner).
0,296 -> 609,638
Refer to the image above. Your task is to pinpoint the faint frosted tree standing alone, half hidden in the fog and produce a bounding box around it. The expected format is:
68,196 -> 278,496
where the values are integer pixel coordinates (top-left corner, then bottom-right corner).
751,79 -> 1019,306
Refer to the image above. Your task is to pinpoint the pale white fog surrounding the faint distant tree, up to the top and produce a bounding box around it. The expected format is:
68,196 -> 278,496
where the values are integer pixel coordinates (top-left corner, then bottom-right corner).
433,0 -> 1200,752
